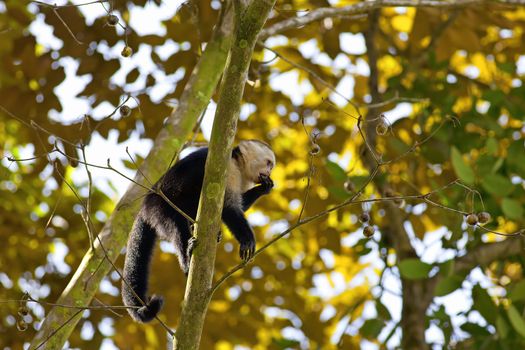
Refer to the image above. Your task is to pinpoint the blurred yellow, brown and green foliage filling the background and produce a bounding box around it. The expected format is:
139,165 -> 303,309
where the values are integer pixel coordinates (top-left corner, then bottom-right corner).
0,0 -> 525,349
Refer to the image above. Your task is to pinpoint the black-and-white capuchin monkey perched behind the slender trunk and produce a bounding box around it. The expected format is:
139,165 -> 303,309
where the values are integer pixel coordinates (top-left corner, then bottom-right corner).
122,140 -> 275,323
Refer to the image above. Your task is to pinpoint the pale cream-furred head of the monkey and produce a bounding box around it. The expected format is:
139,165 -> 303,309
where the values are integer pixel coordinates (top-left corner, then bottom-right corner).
238,140 -> 275,183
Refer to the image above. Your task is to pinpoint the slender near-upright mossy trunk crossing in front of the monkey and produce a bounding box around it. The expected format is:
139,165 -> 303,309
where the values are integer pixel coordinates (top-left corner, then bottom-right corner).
173,0 -> 275,350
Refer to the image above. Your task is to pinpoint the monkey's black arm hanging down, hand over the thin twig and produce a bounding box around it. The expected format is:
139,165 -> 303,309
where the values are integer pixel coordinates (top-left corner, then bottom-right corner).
222,206 -> 255,260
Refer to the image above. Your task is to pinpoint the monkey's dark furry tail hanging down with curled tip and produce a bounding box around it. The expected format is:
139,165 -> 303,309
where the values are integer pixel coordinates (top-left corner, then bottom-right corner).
122,214 -> 164,323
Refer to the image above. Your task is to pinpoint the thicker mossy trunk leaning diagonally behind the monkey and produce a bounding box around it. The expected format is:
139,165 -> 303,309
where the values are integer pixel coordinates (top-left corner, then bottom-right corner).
30,6 -> 233,349
